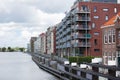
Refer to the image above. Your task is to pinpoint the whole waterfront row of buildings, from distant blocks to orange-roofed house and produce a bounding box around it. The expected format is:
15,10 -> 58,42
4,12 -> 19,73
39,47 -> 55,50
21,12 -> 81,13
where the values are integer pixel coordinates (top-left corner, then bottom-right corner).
28,0 -> 120,65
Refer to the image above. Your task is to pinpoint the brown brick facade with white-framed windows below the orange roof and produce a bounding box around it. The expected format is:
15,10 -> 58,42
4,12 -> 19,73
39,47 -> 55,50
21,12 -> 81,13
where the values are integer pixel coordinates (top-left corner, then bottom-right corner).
102,26 -> 116,65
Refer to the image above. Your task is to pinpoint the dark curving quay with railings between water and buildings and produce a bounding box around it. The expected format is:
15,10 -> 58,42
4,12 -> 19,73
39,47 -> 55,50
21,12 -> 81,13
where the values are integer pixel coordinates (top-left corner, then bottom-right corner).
32,54 -> 120,80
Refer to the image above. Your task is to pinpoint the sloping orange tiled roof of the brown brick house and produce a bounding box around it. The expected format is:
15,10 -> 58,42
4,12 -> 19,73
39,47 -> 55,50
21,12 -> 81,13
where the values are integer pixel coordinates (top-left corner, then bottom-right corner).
101,12 -> 120,28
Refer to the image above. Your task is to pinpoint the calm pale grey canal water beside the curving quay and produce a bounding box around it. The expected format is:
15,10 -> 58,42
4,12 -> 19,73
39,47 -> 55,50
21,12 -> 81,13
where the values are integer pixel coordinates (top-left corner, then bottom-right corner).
0,52 -> 58,80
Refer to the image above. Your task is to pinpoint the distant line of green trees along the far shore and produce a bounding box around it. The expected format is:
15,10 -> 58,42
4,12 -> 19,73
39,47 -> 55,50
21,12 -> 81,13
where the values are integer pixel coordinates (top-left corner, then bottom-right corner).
0,47 -> 25,52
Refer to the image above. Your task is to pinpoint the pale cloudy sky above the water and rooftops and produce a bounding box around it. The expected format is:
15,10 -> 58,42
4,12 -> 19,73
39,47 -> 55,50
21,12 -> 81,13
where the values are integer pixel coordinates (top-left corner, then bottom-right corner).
0,0 -> 75,47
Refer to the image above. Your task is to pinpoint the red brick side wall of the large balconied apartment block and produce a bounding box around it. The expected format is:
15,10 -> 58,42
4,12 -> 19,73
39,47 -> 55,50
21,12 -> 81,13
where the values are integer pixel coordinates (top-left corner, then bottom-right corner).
79,2 -> 120,56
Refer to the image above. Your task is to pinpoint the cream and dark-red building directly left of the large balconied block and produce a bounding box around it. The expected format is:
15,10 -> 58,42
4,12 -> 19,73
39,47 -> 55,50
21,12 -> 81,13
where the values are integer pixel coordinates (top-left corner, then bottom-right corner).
46,26 -> 56,54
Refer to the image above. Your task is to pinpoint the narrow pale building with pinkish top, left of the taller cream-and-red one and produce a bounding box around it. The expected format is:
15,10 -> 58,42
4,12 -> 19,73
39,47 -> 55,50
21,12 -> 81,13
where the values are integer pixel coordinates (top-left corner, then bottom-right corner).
39,33 -> 46,54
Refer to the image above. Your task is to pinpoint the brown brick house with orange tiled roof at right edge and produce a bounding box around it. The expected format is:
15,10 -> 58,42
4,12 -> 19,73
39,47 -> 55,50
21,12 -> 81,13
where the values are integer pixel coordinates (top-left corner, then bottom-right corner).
101,13 -> 120,65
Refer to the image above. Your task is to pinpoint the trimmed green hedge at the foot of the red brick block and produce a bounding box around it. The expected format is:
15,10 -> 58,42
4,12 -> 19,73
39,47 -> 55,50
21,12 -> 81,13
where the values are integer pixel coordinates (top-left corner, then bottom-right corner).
69,56 -> 94,64
